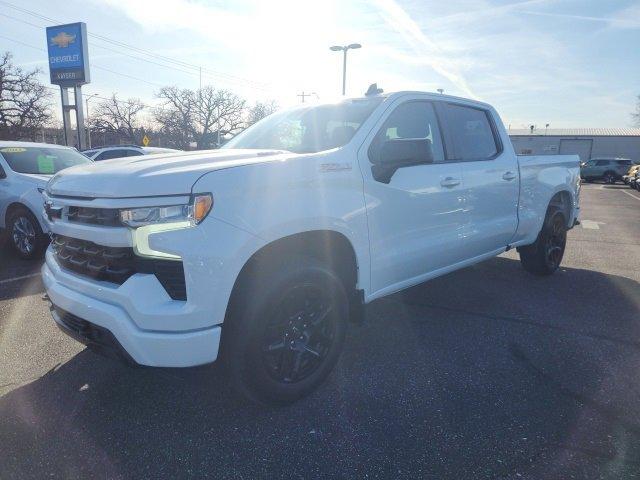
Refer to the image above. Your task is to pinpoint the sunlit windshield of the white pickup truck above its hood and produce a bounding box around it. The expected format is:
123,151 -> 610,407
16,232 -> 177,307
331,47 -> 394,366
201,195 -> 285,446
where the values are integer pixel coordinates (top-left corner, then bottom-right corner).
223,97 -> 384,153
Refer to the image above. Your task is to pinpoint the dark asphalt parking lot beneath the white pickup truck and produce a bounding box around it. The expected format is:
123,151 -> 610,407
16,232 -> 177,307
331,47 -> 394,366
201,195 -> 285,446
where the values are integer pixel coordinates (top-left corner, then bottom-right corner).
0,184 -> 640,479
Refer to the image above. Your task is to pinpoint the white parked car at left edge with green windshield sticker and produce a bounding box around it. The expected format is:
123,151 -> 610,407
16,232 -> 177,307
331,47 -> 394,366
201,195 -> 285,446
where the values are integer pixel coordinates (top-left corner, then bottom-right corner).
0,141 -> 91,259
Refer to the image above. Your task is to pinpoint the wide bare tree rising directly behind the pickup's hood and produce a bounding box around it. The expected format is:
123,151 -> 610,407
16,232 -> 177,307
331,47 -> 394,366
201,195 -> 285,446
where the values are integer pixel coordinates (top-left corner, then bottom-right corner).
154,86 -> 246,149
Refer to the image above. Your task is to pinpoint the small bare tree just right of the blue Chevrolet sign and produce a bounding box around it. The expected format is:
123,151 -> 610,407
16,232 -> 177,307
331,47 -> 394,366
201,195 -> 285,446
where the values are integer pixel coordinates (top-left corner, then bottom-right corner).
89,93 -> 145,144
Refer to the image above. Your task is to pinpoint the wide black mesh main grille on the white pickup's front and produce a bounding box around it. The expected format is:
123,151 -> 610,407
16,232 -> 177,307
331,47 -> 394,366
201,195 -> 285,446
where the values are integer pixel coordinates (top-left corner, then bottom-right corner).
51,235 -> 187,300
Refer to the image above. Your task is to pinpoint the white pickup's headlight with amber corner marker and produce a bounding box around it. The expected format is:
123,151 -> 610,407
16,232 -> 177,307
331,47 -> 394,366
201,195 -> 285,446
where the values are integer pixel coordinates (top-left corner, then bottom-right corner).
120,193 -> 213,228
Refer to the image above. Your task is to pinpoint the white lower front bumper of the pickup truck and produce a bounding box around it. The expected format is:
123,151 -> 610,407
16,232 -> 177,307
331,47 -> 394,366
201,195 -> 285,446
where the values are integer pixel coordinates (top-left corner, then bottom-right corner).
42,258 -> 221,367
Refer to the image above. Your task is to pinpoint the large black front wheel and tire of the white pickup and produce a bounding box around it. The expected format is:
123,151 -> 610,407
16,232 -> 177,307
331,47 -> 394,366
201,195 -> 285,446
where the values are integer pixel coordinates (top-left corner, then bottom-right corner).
222,256 -> 349,405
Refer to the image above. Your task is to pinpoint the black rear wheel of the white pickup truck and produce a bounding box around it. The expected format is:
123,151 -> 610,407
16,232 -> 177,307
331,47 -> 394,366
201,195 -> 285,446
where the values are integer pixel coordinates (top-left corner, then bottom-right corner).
518,207 -> 567,275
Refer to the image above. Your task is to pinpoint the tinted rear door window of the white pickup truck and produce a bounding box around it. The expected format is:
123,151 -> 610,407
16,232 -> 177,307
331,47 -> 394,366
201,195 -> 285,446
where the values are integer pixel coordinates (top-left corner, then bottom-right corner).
446,104 -> 500,160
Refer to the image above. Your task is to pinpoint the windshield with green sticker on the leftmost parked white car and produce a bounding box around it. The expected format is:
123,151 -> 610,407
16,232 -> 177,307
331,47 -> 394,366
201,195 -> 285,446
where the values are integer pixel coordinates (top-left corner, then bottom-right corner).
0,147 -> 91,175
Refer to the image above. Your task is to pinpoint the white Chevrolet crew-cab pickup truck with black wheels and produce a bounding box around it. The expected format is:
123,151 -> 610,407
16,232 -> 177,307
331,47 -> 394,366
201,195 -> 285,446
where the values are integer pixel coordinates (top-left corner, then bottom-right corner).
42,92 -> 580,403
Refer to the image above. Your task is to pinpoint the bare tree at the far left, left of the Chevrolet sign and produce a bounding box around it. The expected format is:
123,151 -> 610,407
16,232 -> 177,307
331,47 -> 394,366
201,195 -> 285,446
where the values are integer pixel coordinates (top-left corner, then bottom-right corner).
0,52 -> 52,140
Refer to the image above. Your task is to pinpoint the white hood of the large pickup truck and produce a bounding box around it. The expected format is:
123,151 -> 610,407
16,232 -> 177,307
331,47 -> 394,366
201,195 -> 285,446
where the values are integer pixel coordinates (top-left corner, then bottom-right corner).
47,150 -> 292,198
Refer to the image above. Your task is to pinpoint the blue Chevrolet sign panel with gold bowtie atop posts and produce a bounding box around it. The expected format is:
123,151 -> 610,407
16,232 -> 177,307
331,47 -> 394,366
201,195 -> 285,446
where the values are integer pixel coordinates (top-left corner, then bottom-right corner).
47,22 -> 90,86
